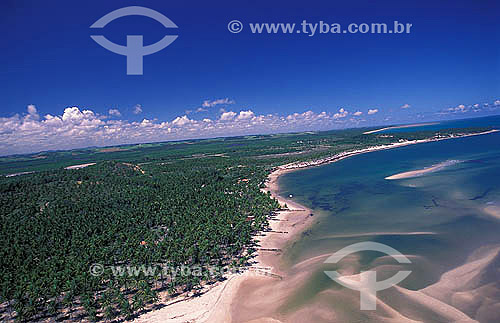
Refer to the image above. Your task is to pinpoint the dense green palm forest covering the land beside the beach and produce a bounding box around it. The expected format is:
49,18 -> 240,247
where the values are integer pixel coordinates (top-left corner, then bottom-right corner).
0,129 -> 492,321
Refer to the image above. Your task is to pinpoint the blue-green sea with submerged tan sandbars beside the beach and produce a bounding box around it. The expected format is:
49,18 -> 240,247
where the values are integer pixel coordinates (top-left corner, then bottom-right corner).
275,123 -> 500,322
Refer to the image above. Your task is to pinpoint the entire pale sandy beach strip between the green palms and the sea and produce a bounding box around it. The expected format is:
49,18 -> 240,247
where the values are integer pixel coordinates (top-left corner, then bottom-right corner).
134,129 -> 499,323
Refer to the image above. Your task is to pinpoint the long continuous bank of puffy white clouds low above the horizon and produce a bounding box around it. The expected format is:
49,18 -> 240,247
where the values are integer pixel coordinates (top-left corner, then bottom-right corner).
0,106 -> 370,154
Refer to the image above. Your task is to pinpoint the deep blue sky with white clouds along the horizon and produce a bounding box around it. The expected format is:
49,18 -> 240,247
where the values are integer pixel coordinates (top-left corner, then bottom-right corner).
0,0 -> 500,154
